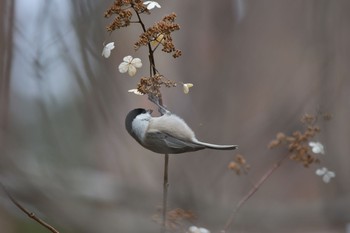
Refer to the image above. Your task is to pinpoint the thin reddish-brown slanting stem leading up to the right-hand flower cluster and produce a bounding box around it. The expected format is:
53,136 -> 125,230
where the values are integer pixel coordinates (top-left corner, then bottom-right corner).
221,155 -> 288,233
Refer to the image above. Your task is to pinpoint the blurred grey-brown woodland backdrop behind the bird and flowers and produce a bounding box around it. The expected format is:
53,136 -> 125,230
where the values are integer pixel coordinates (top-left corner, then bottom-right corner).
0,0 -> 350,233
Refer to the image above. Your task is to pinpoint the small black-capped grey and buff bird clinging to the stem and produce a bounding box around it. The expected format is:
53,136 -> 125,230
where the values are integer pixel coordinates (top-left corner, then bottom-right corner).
125,108 -> 237,154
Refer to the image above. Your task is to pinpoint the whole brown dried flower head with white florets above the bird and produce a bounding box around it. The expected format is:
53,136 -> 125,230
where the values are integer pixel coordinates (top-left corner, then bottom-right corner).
102,0 -> 186,98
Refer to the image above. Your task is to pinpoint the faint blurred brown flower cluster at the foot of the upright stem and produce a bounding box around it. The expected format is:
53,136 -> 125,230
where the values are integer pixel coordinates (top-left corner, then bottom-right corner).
153,208 -> 196,232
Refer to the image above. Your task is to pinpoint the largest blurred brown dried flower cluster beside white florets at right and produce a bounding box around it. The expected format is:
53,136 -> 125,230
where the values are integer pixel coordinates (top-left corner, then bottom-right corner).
268,114 -> 320,167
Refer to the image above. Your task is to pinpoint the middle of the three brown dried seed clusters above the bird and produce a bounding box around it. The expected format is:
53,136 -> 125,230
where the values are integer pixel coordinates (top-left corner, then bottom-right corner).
134,13 -> 181,58
